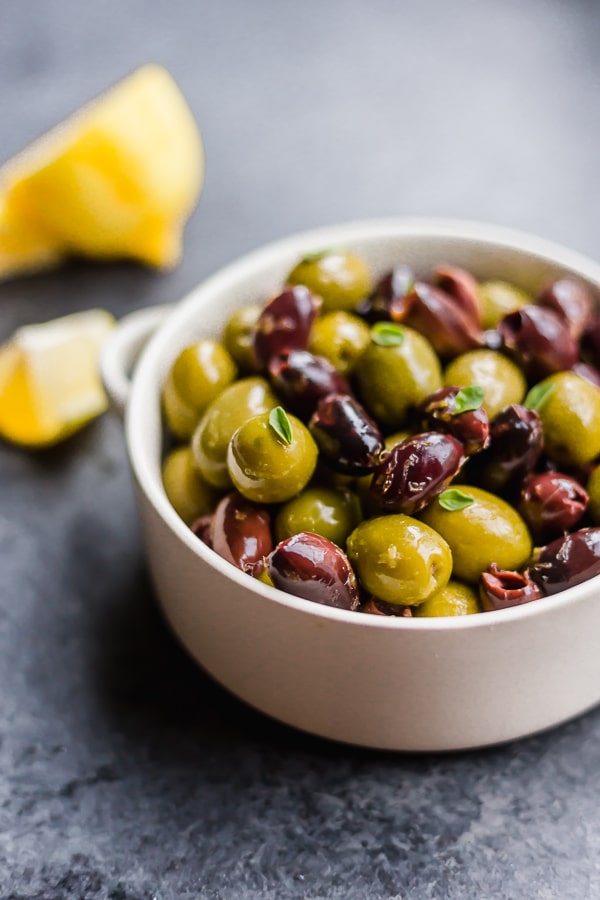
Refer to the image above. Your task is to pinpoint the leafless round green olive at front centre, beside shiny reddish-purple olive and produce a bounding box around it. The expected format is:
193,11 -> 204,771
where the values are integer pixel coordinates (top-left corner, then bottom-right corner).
346,515 -> 452,606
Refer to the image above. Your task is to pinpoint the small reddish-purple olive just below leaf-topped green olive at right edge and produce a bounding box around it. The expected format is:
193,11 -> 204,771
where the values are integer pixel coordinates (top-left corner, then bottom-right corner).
518,472 -> 589,542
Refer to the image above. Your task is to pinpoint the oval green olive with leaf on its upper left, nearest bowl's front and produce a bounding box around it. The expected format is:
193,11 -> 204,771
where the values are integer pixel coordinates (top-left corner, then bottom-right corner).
420,484 -> 532,583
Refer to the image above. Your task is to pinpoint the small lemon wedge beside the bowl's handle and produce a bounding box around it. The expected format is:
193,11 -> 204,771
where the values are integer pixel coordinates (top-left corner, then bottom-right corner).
0,309 -> 115,448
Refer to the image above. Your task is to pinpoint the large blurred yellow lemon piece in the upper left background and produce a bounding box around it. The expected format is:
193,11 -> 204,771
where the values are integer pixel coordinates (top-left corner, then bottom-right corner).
0,65 -> 204,278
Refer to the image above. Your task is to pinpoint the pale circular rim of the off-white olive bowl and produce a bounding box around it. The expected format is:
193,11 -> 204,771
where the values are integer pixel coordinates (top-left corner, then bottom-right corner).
125,217 -> 600,632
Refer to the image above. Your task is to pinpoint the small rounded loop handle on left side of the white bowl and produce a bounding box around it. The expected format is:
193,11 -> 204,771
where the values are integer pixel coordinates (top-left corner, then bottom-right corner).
100,305 -> 172,418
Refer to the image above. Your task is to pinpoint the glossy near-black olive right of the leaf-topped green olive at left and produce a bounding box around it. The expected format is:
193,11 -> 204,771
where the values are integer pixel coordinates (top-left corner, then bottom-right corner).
308,394 -> 385,475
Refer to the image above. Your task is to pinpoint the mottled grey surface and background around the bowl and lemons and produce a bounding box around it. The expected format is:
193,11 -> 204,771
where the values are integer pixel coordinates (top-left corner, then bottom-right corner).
0,0 -> 600,900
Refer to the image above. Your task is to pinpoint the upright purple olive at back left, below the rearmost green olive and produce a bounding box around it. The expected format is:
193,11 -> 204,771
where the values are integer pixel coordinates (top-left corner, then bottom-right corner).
254,284 -> 319,369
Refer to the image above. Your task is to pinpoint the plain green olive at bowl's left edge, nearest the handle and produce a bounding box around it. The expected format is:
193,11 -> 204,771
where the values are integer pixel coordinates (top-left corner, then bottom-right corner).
162,338 -> 237,440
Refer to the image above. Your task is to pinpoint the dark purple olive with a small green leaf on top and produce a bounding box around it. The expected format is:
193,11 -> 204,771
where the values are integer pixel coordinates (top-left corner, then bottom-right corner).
419,386 -> 490,456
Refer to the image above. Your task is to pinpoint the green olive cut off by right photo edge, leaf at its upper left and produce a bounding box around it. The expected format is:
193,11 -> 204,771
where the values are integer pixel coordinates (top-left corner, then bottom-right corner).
538,372 -> 600,466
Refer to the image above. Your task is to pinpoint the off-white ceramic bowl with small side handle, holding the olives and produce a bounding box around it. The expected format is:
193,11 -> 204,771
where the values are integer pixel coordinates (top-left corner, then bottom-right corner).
103,220 -> 600,751
